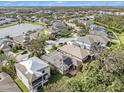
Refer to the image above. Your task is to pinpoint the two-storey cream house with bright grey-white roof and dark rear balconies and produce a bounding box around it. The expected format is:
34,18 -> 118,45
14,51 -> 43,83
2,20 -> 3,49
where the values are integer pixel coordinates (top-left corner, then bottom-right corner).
15,56 -> 50,91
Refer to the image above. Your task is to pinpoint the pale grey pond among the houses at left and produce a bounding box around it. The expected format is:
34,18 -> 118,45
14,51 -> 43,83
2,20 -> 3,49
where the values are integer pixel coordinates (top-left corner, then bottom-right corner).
0,23 -> 42,38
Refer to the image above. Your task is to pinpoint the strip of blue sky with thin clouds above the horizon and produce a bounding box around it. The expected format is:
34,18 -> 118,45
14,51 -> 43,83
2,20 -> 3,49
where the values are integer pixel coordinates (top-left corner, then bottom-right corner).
0,1 -> 124,6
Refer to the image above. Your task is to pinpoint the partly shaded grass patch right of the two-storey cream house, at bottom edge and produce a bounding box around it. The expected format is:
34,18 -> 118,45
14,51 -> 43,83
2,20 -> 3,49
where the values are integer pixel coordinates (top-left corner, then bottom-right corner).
39,72 -> 70,92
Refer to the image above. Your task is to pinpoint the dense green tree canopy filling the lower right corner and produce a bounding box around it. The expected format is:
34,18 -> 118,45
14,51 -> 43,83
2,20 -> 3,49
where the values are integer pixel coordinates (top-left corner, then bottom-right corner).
68,47 -> 124,92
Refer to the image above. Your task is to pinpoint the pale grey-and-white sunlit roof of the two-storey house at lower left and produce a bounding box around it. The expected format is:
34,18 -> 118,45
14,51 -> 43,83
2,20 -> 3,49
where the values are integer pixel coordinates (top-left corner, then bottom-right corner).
15,56 -> 49,81
